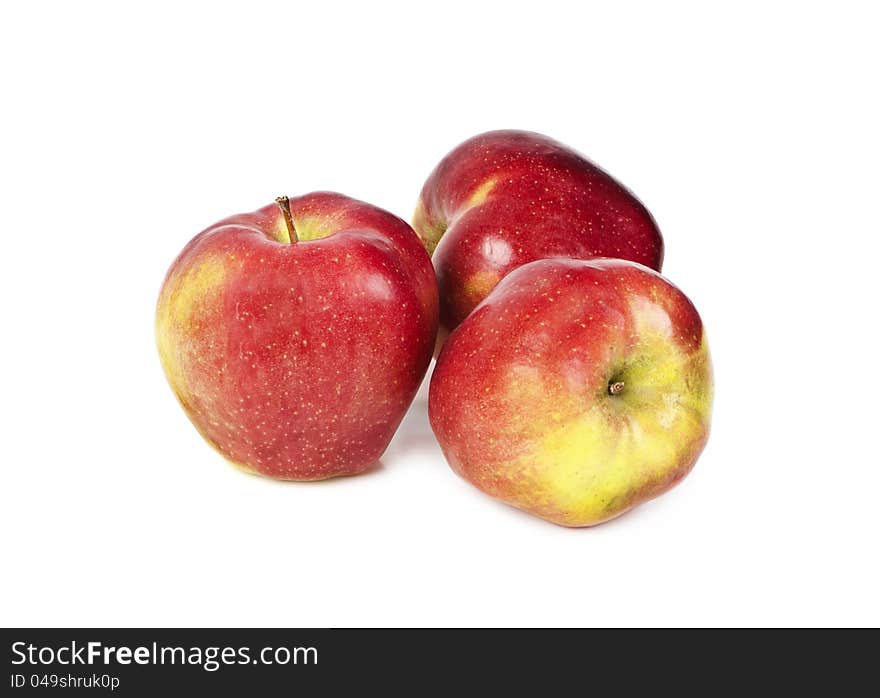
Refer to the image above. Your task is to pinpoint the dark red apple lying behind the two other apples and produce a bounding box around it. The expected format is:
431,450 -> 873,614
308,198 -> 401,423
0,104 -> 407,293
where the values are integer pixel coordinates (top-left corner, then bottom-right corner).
413,131 -> 663,337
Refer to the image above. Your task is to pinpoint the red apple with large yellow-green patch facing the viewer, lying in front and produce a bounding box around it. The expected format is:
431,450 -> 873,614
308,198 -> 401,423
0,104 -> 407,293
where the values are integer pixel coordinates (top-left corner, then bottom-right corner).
429,258 -> 712,526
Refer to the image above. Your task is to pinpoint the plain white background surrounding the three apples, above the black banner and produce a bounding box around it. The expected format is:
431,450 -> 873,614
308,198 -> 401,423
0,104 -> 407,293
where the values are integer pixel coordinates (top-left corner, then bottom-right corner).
0,0 -> 880,626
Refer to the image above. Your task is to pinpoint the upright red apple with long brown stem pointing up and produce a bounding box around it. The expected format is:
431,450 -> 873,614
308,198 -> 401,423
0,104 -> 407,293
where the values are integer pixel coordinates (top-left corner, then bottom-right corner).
156,192 -> 438,480
